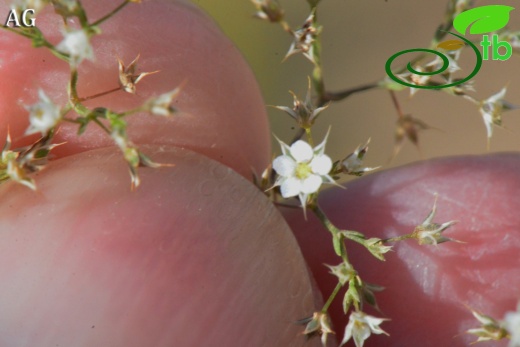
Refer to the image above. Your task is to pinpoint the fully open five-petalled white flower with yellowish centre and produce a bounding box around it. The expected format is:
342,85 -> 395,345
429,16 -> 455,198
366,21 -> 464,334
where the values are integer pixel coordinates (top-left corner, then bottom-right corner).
273,134 -> 334,208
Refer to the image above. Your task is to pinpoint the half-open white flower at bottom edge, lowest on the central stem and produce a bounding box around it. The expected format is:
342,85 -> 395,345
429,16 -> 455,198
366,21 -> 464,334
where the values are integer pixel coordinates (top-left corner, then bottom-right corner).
340,311 -> 388,347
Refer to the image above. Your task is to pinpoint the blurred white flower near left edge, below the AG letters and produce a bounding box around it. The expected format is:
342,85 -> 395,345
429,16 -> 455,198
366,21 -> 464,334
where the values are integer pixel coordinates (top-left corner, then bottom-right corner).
25,89 -> 61,135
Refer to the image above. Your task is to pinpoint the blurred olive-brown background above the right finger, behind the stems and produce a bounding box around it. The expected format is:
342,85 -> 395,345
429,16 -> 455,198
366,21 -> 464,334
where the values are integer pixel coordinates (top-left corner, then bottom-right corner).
193,0 -> 520,179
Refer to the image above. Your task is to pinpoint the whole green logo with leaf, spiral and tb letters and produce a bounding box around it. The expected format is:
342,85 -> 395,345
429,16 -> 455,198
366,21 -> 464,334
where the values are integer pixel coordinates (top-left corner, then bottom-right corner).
385,5 -> 514,89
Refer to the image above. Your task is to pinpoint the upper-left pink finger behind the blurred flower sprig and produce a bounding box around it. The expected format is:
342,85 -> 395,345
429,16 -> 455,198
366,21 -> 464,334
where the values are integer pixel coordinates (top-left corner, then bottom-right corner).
0,0 -> 270,179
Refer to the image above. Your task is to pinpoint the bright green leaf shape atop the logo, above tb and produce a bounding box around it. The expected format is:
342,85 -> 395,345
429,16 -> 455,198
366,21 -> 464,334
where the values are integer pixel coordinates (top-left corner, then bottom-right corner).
453,5 -> 515,35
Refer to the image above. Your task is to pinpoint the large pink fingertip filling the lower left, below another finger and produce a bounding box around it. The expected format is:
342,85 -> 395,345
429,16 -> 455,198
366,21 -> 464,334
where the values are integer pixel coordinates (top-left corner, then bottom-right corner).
0,148 -> 319,347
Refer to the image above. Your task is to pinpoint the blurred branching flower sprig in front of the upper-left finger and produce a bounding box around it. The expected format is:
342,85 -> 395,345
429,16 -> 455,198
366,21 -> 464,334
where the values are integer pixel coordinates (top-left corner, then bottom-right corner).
0,0 -> 180,189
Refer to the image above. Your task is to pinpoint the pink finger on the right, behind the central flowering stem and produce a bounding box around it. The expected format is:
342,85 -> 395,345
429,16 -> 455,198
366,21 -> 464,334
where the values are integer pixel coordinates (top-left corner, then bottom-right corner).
285,154 -> 520,347
